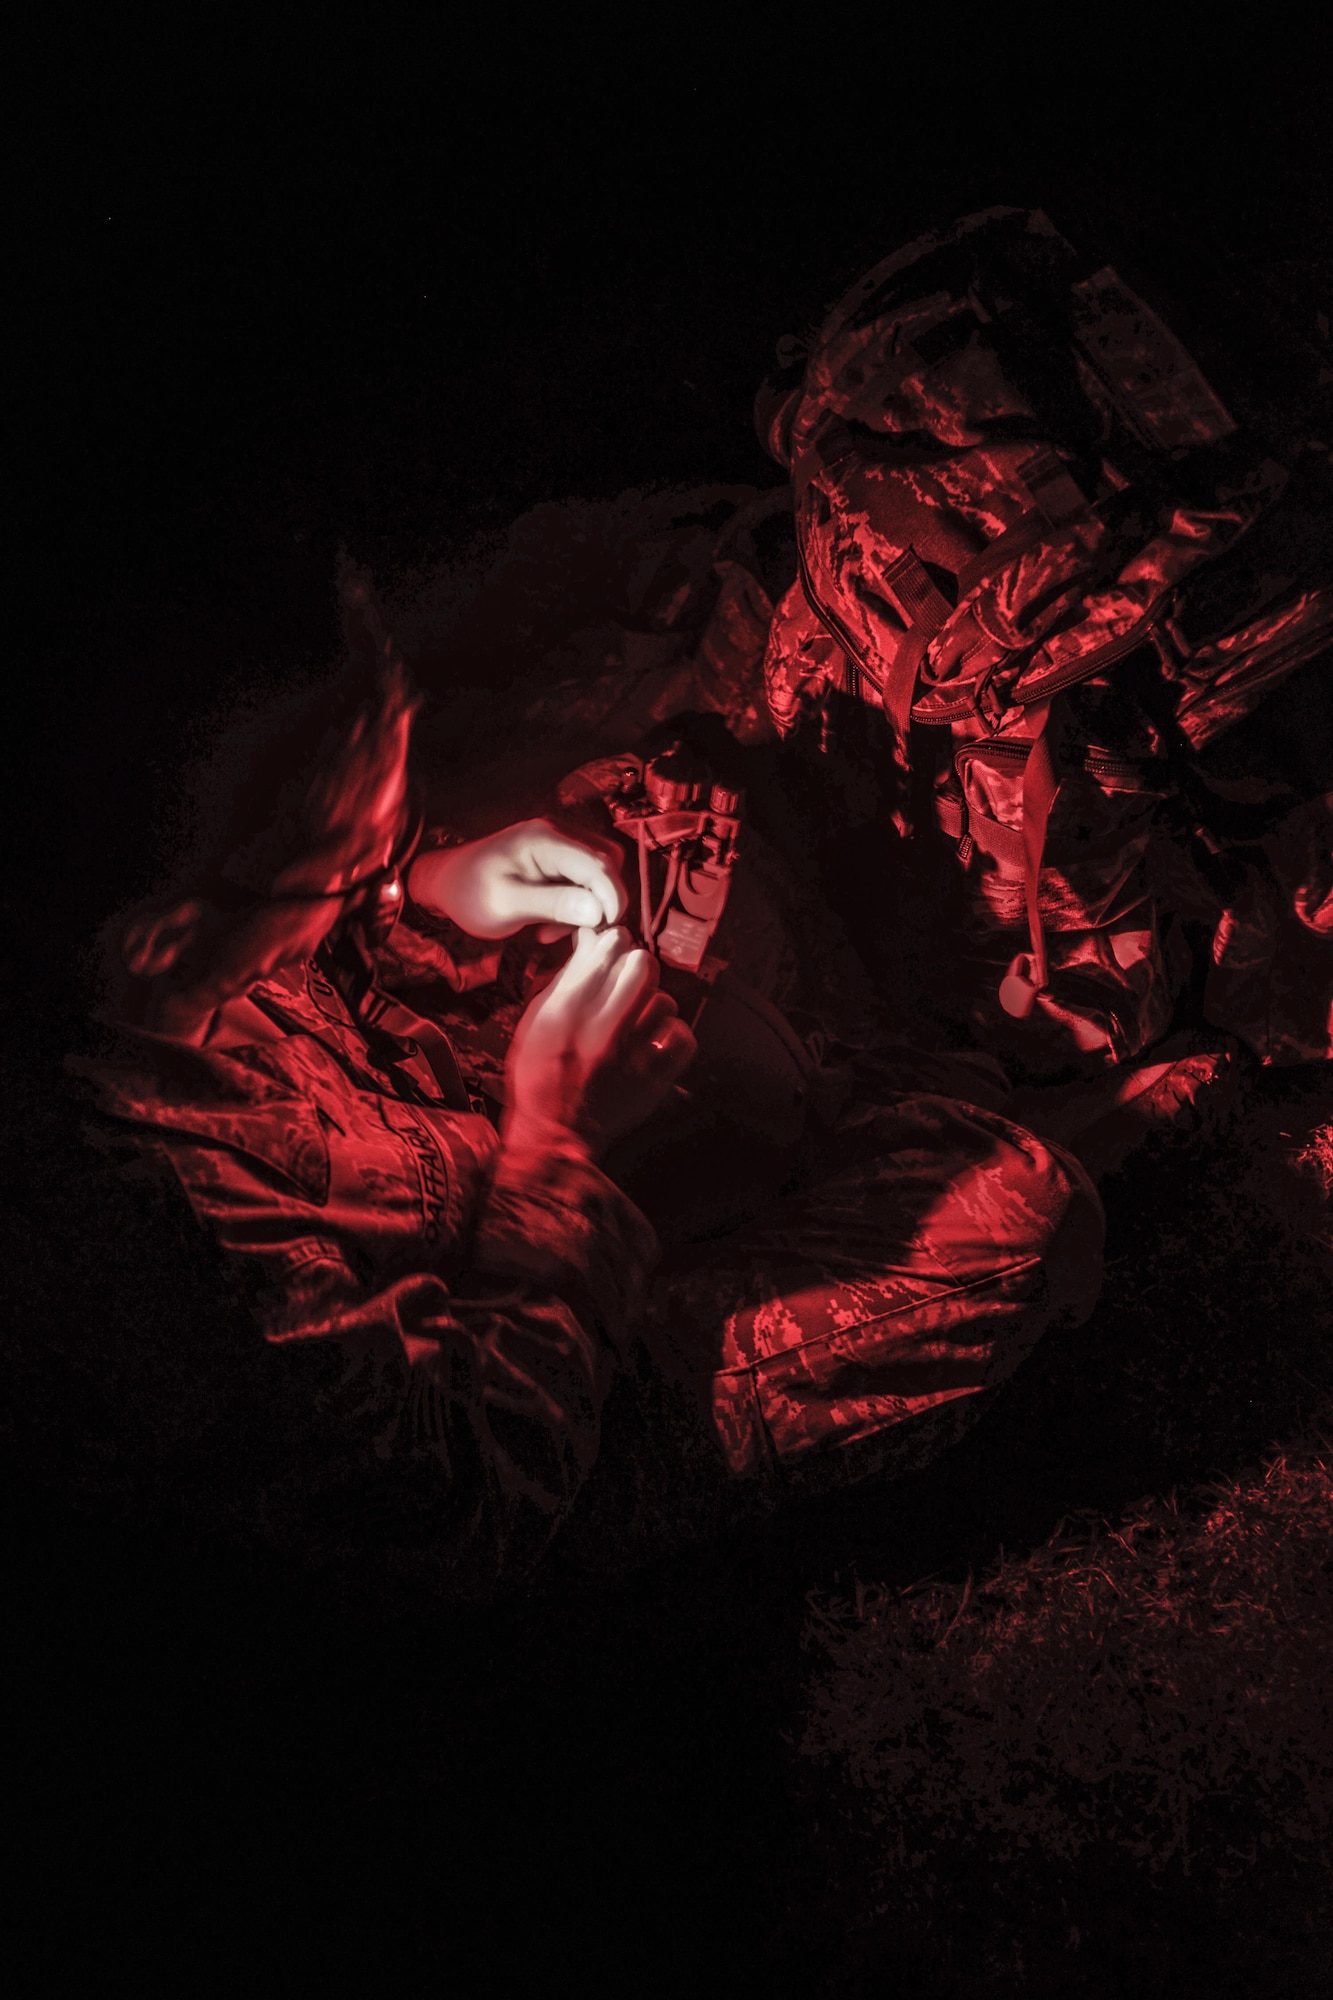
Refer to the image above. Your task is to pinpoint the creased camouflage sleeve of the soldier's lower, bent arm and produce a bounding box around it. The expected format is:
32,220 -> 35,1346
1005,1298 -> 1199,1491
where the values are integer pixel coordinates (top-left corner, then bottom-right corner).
158,1128 -> 656,1596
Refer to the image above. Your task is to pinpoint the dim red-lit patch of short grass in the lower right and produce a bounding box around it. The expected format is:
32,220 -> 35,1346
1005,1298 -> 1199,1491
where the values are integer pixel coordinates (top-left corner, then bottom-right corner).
803,1440 -> 1333,1896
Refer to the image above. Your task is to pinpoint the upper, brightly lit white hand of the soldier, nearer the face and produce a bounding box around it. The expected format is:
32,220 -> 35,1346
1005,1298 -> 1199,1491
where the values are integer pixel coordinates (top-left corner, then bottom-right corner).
408,820 -> 628,942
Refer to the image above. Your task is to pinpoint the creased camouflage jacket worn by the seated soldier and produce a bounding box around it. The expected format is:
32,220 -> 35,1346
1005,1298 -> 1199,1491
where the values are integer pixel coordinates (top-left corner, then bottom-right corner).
72,966 -> 656,1594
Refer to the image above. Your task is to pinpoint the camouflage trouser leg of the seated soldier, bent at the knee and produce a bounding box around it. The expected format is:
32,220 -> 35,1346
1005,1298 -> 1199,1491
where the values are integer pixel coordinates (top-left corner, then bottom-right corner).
548,1046 -> 1103,1570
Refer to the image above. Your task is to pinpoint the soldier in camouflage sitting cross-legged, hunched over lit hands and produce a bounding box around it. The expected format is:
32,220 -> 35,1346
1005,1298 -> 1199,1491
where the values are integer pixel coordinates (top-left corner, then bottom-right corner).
78,584 -> 1103,1592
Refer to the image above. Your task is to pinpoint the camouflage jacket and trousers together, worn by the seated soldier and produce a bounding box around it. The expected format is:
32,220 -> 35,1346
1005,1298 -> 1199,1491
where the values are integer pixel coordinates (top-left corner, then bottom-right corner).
78,920 -> 1101,1594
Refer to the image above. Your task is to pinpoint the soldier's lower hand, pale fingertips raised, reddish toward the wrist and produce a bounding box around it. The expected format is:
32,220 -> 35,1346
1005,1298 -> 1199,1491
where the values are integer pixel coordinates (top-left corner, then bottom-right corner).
504,928 -> 695,1154
